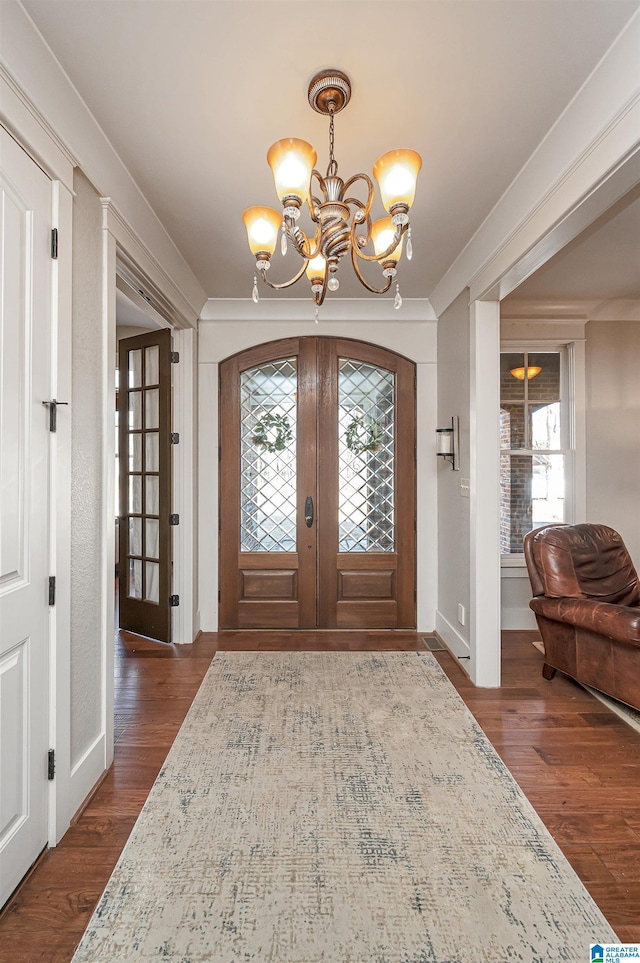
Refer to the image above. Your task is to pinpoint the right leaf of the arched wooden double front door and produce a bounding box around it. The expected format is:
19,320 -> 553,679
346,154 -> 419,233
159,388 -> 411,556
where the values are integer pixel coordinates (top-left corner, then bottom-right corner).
318,338 -> 416,628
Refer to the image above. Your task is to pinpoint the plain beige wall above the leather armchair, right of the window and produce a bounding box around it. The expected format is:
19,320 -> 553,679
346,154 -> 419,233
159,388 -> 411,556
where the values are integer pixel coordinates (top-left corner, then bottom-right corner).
586,320 -> 640,556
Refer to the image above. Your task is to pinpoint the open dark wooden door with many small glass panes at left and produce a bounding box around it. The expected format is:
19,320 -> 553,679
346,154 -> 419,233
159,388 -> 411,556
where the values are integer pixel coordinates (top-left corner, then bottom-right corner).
118,330 -> 171,642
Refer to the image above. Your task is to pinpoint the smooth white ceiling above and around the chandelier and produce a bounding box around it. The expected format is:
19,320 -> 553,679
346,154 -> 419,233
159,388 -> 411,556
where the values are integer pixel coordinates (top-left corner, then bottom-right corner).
23,0 -> 639,298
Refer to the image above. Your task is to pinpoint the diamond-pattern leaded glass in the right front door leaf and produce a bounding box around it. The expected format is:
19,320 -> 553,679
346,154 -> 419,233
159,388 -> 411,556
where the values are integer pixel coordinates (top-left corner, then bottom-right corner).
338,358 -> 395,552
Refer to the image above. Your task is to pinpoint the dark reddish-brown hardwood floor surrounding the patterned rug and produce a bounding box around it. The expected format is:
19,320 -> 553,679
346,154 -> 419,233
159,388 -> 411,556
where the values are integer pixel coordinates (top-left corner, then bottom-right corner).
0,632 -> 640,963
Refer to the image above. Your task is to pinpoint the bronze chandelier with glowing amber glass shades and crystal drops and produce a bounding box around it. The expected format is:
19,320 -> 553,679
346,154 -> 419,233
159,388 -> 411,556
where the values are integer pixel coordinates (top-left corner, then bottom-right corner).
242,69 -> 422,321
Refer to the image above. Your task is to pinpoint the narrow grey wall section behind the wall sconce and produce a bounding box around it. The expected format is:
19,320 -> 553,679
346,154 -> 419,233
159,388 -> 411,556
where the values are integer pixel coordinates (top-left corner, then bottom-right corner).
431,290 -> 471,656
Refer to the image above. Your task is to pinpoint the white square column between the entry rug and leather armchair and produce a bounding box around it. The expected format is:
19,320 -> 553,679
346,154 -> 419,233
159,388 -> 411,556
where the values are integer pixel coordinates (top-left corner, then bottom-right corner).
469,301 -> 501,686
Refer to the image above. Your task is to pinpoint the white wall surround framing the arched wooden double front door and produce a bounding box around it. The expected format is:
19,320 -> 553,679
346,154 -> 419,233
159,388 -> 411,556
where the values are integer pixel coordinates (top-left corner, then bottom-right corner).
198,321 -> 437,632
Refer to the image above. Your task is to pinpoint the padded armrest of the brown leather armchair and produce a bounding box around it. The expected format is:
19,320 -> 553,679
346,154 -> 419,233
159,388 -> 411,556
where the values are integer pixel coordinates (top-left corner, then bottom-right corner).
529,596 -> 640,646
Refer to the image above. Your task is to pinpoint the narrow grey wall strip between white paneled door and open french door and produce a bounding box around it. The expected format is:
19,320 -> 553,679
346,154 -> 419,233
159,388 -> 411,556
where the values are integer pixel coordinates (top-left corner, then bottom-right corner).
70,170 -> 103,772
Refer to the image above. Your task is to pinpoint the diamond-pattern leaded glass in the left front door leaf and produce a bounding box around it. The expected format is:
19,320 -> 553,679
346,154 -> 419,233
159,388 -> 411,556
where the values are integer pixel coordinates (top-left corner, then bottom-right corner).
240,358 -> 298,552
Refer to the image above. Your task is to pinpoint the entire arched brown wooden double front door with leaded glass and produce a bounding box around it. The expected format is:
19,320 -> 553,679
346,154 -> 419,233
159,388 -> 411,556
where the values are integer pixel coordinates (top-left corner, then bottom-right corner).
220,338 -> 416,628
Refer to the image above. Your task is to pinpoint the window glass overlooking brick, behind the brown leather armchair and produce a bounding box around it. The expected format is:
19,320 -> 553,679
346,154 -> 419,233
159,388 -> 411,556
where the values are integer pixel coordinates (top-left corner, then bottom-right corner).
500,348 -> 572,558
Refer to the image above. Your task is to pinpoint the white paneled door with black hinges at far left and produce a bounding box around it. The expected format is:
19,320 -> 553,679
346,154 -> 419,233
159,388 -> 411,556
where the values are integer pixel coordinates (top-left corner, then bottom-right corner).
0,129 -> 52,906
